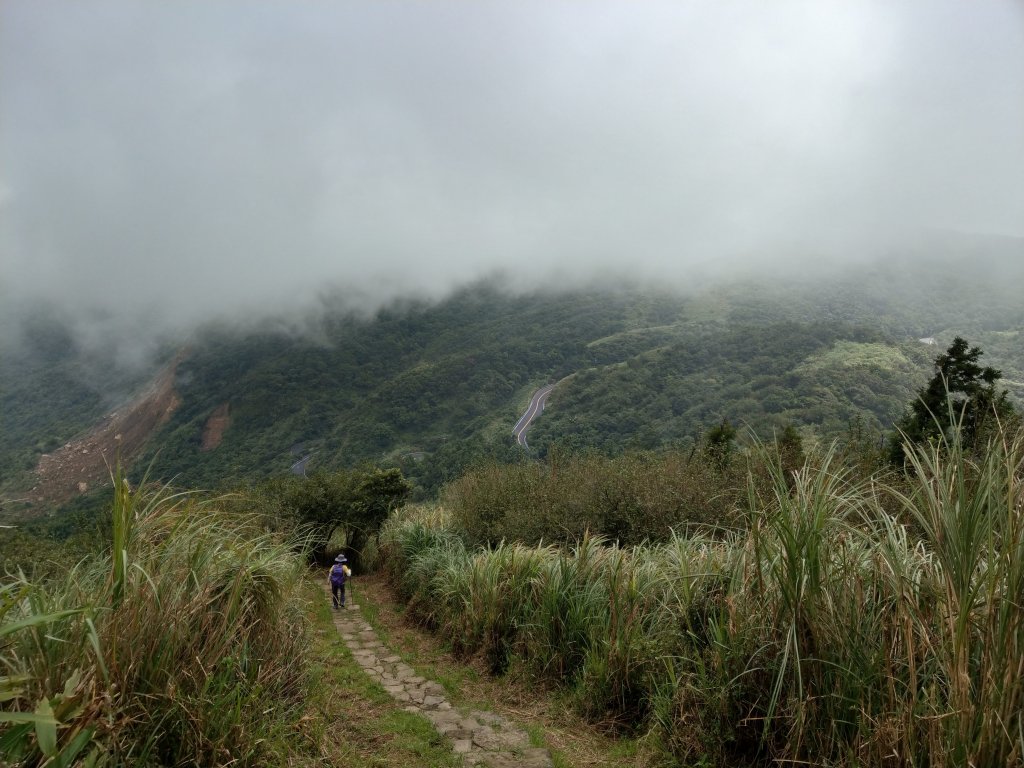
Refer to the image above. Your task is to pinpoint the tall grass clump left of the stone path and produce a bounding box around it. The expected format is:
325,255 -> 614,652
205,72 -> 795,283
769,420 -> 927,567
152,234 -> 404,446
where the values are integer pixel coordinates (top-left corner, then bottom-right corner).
0,475 -> 307,765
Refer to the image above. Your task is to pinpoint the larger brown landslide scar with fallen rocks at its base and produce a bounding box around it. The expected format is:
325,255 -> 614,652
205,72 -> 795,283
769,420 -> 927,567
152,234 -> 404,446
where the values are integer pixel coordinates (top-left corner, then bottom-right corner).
30,353 -> 183,509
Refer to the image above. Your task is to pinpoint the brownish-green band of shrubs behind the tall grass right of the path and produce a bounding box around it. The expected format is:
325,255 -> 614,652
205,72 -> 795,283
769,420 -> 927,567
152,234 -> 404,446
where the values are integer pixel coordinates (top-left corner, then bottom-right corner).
440,423 -> 885,546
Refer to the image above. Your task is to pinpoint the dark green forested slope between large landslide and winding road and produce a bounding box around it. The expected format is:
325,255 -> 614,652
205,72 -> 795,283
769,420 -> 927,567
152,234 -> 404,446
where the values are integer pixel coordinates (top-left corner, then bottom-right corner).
135,286 -> 627,493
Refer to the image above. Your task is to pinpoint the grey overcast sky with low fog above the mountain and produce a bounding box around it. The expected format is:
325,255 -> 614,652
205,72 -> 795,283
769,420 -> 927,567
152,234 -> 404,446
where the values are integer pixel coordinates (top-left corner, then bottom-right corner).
0,0 -> 1024,354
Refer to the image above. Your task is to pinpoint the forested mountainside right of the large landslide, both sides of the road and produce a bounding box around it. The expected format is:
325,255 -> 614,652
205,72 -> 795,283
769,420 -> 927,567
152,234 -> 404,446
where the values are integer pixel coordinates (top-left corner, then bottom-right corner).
112,285 -> 1024,500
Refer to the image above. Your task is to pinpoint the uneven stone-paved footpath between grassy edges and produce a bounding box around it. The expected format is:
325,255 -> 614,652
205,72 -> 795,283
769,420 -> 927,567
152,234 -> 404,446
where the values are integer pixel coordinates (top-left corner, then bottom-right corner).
334,593 -> 552,768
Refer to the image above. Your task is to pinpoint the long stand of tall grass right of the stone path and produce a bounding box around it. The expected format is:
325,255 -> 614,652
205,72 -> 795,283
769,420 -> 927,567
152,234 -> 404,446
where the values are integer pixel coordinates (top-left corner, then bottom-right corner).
380,430 -> 1024,766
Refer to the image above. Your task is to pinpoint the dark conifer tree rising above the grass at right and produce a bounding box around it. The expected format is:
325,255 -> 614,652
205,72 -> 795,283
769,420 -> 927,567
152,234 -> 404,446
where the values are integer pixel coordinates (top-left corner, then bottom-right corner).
889,336 -> 1015,465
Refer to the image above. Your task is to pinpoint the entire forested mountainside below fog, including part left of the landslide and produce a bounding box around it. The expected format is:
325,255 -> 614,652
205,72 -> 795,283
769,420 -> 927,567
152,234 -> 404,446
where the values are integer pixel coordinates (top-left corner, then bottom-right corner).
0,241 -> 1024,512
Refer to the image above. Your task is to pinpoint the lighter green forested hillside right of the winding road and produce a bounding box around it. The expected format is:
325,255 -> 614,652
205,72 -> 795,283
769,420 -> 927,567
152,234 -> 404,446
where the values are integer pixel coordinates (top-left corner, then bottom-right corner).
530,241 -> 1024,453
